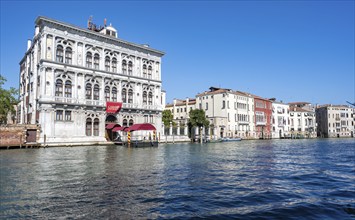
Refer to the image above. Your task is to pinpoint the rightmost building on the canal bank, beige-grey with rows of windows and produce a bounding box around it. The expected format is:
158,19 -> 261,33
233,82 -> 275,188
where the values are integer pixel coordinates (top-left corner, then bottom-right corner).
316,105 -> 355,137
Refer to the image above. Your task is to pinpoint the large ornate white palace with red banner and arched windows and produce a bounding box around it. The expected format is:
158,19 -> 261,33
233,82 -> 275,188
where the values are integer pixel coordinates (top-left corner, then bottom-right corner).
18,17 -> 165,143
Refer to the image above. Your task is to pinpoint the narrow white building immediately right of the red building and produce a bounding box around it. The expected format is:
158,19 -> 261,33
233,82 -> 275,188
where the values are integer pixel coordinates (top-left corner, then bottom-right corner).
270,99 -> 290,138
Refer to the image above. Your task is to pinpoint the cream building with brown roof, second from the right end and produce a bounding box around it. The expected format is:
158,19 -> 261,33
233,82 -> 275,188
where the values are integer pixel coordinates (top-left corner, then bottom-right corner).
289,102 -> 317,138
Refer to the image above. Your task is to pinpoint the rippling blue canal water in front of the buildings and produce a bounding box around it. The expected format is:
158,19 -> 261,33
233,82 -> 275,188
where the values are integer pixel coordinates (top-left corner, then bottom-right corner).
0,139 -> 355,219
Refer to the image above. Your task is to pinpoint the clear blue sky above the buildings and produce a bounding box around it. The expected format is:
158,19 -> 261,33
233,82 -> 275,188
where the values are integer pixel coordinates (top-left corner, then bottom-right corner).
0,1 -> 355,104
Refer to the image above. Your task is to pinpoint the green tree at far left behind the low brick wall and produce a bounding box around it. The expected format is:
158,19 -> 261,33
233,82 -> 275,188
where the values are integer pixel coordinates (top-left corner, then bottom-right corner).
0,75 -> 18,124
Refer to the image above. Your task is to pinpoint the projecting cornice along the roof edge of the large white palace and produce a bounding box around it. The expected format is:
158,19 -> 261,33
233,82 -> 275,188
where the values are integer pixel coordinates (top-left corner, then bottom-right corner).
35,16 -> 165,56
